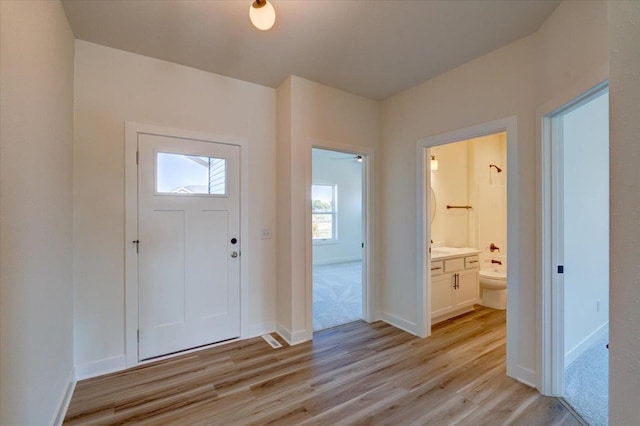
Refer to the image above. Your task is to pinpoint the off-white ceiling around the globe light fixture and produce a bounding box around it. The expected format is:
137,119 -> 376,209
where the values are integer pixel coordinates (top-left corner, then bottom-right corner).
62,0 -> 559,99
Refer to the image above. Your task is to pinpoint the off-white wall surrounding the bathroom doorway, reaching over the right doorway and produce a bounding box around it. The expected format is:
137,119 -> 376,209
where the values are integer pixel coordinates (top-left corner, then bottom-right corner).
380,1 -> 607,383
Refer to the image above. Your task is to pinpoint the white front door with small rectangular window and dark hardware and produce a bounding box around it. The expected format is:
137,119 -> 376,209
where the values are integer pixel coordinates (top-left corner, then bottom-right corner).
138,134 -> 240,360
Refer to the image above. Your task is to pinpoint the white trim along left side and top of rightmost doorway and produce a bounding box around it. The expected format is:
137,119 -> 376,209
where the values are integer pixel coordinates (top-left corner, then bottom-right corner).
536,64 -> 609,396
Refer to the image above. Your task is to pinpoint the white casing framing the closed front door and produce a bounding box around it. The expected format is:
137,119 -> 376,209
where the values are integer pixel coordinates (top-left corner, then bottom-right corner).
124,121 -> 249,368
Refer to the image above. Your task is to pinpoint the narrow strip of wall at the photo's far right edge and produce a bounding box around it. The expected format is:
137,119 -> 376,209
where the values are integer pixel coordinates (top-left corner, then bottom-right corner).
608,1 -> 640,425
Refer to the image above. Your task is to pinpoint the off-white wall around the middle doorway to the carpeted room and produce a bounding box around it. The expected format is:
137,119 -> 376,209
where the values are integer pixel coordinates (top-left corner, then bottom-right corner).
277,76 -> 380,342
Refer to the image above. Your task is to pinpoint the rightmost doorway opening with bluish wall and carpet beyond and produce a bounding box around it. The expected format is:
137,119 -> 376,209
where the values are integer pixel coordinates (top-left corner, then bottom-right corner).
542,83 -> 609,425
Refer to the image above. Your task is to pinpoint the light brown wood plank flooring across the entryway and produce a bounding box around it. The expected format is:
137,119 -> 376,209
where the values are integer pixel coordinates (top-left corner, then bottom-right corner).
65,307 -> 579,426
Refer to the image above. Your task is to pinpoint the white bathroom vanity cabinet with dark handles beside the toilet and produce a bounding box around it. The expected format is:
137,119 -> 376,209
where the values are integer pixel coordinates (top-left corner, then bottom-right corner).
430,249 -> 480,323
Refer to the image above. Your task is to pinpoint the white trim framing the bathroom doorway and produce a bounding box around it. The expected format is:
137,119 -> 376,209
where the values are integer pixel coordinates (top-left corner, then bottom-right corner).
416,115 -> 520,377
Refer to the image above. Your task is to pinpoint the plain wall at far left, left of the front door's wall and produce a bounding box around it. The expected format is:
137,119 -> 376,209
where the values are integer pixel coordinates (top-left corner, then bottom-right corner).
0,1 -> 73,425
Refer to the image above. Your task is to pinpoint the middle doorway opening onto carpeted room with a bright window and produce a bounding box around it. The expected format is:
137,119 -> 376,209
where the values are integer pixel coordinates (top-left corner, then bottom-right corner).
311,148 -> 366,331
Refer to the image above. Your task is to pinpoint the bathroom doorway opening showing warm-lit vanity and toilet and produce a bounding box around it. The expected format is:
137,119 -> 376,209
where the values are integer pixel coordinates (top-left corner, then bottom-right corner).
425,132 -> 507,324
